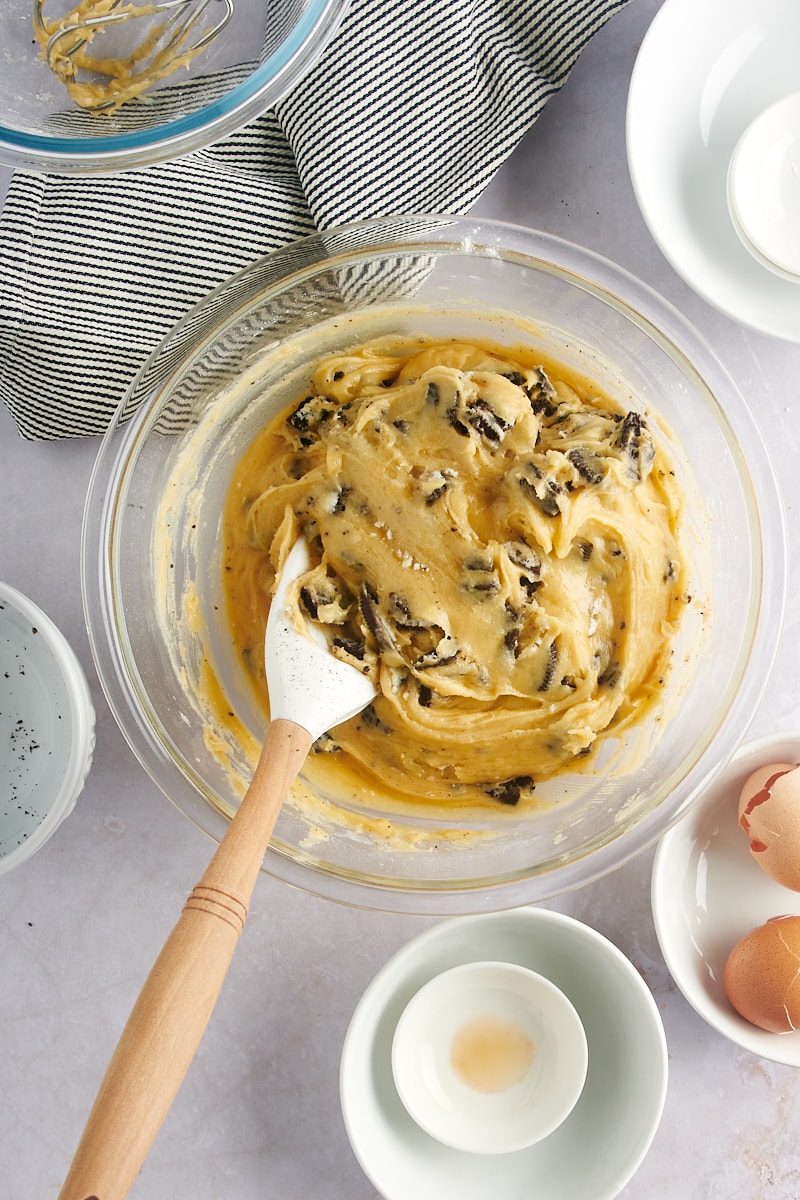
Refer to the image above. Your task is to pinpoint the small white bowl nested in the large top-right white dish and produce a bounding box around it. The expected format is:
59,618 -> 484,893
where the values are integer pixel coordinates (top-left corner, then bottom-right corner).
728,92 -> 800,283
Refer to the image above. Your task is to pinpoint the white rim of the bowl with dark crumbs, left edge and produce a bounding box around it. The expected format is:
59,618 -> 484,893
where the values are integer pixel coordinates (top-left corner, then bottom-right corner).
0,581 -> 95,875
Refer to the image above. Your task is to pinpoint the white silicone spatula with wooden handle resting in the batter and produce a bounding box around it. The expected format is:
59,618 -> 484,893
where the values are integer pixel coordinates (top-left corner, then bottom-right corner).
59,539 -> 375,1200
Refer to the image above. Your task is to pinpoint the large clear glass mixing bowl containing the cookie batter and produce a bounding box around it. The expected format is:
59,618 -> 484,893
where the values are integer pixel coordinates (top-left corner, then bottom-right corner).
83,216 -> 787,914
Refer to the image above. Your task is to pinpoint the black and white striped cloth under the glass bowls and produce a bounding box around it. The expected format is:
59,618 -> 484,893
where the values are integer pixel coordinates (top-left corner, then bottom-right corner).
0,0 -> 628,438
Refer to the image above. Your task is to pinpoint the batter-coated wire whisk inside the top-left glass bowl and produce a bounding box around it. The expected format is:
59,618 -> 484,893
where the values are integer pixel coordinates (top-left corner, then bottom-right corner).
34,0 -> 234,114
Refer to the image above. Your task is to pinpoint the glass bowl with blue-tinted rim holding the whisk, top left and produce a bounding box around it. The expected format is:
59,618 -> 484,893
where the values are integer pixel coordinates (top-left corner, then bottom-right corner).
0,0 -> 348,174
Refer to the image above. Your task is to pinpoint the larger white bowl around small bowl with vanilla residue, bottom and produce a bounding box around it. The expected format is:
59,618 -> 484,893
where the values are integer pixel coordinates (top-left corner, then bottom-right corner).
341,908 -> 667,1200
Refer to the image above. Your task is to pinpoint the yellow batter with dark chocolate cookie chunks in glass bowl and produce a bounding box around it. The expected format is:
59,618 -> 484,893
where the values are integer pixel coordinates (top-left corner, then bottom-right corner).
223,337 -> 686,805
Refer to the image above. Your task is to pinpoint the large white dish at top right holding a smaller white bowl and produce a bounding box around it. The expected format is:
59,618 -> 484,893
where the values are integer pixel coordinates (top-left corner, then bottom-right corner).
627,0 -> 800,342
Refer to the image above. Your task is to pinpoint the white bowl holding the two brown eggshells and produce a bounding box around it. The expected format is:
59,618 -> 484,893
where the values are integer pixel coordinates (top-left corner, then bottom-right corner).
651,733 -> 800,1067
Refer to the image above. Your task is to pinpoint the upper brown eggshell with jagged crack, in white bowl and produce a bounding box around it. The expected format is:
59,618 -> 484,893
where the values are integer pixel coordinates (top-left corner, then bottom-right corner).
739,762 -> 800,892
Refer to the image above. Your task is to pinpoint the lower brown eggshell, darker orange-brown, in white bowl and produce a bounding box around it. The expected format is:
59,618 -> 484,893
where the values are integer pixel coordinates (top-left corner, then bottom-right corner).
724,917 -> 800,1033
